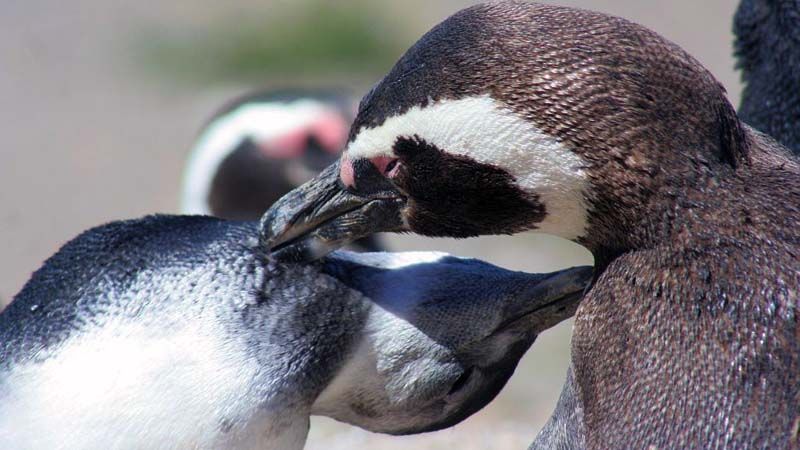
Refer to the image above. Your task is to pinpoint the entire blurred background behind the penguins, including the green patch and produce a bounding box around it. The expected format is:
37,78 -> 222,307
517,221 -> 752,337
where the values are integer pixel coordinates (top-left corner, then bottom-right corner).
0,0 -> 740,449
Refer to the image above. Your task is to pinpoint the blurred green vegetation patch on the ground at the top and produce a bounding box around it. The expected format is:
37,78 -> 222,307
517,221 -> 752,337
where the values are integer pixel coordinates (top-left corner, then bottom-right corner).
138,0 -> 408,82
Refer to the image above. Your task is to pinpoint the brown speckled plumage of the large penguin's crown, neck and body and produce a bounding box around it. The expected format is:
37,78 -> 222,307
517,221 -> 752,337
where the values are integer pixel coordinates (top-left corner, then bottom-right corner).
351,2 -> 800,449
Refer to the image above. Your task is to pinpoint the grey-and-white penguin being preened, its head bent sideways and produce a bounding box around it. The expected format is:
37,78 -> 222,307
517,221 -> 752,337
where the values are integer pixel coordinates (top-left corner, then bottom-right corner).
0,215 -> 592,450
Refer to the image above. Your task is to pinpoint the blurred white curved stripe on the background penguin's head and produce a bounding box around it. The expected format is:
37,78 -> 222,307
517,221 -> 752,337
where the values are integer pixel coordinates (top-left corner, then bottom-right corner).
181,99 -> 335,215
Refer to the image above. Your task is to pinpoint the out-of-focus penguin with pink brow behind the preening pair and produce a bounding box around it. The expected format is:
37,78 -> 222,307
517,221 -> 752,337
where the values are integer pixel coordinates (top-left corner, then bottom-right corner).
181,89 -> 382,251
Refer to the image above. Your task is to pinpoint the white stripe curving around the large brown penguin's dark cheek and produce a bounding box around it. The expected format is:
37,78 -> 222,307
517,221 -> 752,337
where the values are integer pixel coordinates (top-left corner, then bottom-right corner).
347,95 -> 588,240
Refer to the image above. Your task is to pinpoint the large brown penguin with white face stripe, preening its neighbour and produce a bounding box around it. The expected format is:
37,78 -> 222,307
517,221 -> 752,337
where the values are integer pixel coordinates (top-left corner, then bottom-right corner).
263,1 -> 800,449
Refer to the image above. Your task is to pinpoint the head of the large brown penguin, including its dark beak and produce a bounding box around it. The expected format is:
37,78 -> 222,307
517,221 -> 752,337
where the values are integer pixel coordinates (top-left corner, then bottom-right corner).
266,1 -> 743,260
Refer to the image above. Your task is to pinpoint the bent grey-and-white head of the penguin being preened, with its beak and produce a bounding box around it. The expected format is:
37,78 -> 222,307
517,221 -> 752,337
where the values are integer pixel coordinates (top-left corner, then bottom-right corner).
312,252 -> 592,434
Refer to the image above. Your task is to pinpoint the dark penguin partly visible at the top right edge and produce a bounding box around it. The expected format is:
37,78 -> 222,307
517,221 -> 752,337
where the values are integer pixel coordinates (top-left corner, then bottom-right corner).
734,0 -> 800,154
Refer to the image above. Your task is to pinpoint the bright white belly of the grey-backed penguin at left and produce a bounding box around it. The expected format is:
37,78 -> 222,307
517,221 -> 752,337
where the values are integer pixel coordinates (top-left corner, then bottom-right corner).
0,318 -> 296,449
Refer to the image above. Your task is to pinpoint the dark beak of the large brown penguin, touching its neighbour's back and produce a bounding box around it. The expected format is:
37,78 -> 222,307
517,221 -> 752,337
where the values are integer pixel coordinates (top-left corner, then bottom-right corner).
260,161 -> 405,262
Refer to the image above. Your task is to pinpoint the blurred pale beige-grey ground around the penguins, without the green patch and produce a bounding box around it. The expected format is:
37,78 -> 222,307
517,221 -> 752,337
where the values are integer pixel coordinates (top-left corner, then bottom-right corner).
0,0 -> 740,449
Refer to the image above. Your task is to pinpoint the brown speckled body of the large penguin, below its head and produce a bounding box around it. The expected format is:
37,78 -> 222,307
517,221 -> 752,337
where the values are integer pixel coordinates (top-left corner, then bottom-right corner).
573,129 -> 800,448
